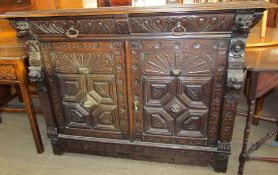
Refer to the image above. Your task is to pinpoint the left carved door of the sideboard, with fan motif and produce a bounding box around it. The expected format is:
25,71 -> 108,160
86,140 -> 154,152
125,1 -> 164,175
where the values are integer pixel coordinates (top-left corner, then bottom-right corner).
42,42 -> 128,139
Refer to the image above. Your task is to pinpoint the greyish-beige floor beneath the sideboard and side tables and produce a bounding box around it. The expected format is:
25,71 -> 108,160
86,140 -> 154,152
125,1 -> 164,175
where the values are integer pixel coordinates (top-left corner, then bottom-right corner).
0,92 -> 278,175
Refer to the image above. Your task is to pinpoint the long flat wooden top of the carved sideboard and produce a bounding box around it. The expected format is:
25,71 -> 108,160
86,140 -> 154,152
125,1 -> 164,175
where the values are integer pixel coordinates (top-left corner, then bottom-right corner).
0,0 -> 278,18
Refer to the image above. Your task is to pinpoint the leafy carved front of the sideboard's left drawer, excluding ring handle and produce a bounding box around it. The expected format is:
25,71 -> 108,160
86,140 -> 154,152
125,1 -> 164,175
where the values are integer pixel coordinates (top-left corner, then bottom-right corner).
29,17 -> 129,36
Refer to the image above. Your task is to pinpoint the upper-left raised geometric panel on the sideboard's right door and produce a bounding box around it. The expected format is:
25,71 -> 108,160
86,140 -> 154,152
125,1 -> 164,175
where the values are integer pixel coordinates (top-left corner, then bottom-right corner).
143,76 -> 175,106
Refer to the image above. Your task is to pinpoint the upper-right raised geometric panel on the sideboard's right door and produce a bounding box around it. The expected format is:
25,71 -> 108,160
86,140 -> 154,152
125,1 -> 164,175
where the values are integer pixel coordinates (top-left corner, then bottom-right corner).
177,77 -> 212,108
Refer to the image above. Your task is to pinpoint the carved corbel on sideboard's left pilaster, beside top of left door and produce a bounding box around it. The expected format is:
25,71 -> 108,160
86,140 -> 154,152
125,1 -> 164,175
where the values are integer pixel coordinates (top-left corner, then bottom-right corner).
28,40 -> 42,82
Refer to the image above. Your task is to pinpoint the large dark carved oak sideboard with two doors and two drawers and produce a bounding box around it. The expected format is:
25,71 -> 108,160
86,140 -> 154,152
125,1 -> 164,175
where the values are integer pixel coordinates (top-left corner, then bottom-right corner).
2,1 -> 272,172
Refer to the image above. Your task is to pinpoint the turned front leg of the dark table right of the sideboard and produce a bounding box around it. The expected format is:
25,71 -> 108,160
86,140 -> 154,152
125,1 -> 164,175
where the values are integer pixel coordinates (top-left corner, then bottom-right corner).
238,100 -> 256,175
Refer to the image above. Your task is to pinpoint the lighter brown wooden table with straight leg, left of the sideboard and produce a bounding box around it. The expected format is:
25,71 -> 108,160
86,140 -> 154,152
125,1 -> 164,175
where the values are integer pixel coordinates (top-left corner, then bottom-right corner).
0,39 -> 44,153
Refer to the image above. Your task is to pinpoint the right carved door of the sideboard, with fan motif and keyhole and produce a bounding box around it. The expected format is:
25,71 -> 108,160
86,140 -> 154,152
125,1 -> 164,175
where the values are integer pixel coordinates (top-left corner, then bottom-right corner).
129,39 -> 228,146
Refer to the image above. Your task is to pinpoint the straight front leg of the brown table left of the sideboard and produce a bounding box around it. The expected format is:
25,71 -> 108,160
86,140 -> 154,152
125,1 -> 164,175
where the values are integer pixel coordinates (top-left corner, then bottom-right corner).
20,83 -> 44,153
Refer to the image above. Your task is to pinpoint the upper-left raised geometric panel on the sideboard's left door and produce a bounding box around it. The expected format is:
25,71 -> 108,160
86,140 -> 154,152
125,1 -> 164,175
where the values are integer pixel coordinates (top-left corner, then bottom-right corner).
56,74 -> 86,103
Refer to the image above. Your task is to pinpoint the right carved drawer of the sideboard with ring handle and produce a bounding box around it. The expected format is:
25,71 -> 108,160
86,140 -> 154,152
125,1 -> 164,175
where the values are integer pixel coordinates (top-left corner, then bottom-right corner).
128,13 -> 234,35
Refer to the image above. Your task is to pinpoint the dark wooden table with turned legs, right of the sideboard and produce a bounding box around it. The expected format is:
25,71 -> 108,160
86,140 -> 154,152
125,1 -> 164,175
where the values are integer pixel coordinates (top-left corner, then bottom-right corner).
238,46 -> 278,175
